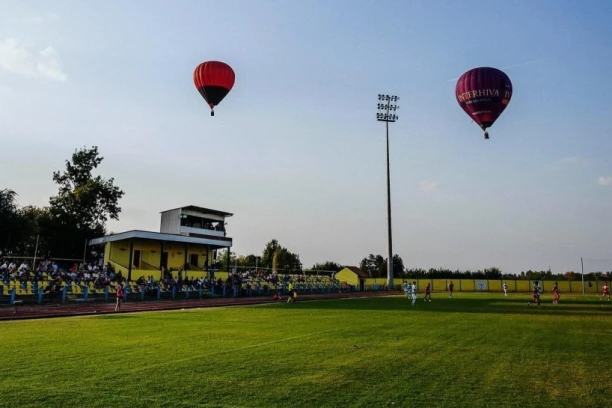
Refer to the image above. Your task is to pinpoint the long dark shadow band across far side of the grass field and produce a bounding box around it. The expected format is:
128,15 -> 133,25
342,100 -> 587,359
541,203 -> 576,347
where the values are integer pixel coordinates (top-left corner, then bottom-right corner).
261,297 -> 612,316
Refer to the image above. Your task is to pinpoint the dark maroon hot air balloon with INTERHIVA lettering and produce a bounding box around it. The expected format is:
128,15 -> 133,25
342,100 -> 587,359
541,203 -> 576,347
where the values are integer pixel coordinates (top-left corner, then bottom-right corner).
455,67 -> 512,139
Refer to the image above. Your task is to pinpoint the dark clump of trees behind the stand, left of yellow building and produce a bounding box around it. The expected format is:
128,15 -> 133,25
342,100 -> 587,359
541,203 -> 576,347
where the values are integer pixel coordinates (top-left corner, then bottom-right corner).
0,146 -> 124,259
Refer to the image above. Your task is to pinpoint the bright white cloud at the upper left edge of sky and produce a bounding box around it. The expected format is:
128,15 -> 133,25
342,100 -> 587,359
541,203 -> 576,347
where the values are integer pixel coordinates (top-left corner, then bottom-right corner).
0,38 -> 67,82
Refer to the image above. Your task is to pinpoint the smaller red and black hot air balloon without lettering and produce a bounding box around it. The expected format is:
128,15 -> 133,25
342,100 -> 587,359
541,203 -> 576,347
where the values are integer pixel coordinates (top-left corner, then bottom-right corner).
193,61 -> 236,116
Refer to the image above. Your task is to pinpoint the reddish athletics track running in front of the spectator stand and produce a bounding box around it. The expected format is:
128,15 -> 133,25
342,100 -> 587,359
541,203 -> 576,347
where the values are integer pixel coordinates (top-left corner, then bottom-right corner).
0,291 -> 403,321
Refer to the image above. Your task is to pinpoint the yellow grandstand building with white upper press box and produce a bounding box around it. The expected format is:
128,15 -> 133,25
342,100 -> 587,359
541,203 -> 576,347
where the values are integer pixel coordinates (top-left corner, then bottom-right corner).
88,206 -> 233,280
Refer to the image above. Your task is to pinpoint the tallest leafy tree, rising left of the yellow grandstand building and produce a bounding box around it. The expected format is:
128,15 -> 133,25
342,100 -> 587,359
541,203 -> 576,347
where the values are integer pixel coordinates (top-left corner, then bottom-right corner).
40,146 -> 124,258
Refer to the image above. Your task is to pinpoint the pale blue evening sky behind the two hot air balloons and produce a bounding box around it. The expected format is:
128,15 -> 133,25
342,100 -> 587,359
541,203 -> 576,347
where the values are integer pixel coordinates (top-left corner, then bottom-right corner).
0,0 -> 612,273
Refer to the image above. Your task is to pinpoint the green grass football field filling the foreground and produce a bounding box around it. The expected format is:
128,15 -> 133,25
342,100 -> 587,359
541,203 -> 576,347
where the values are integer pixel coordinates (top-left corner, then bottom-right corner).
0,293 -> 612,408
